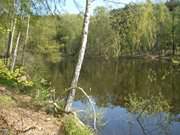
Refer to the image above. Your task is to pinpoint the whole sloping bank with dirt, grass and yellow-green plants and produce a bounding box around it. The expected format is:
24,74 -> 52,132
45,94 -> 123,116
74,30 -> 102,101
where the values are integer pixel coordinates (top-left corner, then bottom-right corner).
0,59 -> 93,135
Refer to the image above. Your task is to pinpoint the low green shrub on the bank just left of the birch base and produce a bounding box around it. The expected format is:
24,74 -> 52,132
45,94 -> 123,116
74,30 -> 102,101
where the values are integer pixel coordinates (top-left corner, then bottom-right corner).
32,78 -> 64,116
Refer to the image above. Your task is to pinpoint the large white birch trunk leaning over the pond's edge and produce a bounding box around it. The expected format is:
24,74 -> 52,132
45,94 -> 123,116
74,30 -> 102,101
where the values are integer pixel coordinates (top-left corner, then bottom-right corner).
64,0 -> 92,112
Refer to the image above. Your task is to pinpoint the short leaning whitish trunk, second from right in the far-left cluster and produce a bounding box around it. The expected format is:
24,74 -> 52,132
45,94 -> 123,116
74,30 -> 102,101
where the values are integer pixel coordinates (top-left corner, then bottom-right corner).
11,32 -> 21,71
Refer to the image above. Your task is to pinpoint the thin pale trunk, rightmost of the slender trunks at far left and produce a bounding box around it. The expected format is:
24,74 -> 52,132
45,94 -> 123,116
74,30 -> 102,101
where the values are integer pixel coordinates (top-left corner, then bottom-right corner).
21,15 -> 30,65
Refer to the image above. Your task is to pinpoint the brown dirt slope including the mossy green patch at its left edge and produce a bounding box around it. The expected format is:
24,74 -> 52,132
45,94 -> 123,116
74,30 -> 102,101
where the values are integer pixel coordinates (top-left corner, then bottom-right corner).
0,88 -> 64,135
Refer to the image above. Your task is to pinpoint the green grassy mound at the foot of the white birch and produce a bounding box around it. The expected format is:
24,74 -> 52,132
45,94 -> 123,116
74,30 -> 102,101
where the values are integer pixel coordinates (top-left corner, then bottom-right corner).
63,116 -> 93,135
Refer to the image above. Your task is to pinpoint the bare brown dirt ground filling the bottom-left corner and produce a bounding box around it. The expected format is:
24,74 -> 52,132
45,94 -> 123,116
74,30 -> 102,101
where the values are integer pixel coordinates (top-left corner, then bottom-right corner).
0,108 -> 63,135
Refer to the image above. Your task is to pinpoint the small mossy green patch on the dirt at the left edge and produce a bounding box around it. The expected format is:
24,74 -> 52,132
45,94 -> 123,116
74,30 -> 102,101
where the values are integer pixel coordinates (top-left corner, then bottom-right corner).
0,95 -> 16,107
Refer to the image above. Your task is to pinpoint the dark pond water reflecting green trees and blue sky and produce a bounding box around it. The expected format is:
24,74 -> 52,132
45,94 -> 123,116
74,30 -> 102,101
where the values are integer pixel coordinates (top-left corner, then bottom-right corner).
51,59 -> 180,135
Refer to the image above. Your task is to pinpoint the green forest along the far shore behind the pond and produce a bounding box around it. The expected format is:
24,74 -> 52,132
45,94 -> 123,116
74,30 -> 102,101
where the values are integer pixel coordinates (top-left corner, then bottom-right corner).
0,1 -> 180,74
